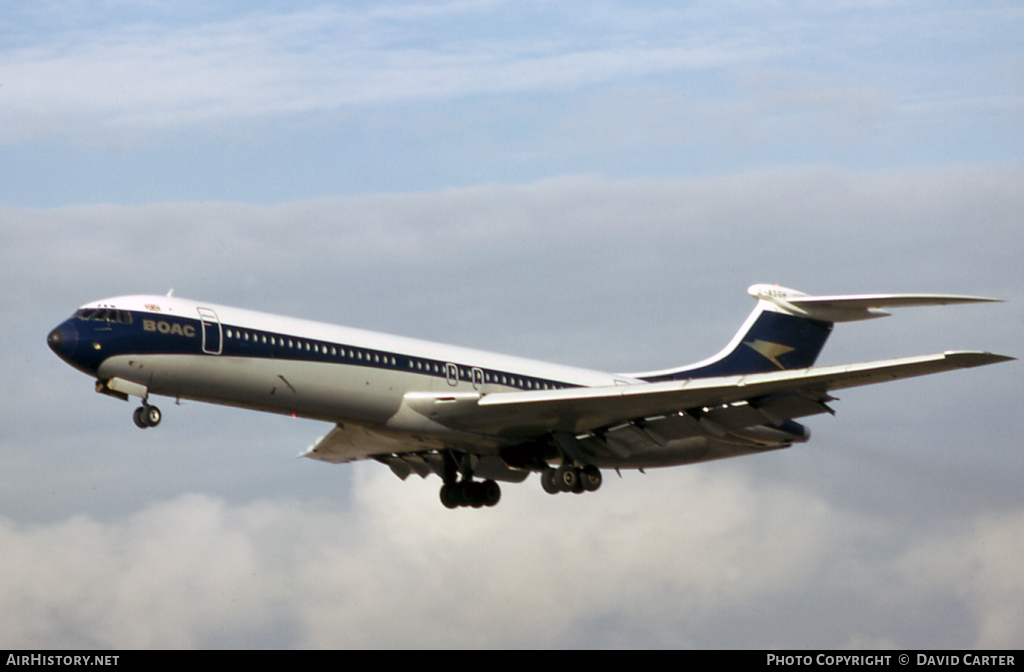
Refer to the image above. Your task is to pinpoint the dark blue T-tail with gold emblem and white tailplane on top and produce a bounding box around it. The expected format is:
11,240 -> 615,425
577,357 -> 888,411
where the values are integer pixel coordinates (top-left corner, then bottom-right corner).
631,285 -> 998,382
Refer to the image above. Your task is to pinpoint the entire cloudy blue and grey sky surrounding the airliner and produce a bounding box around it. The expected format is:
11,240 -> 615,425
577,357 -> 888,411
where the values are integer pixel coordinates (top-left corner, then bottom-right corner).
0,0 -> 1024,648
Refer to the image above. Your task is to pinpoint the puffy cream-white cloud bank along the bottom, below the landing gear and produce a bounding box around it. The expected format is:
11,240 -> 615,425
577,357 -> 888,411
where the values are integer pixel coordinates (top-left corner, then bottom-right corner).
0,465 -> 1024,647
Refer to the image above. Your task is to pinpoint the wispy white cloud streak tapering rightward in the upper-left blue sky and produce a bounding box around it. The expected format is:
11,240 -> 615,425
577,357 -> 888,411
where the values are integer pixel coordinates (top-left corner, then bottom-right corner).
0,3 -> 753,139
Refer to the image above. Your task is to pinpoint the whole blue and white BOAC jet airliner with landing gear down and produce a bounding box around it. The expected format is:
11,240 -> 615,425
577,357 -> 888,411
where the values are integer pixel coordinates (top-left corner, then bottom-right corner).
47,285 -> 1015,508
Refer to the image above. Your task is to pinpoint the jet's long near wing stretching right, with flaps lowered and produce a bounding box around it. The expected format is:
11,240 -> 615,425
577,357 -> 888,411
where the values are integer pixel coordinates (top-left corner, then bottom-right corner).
406,351 -> 1014,440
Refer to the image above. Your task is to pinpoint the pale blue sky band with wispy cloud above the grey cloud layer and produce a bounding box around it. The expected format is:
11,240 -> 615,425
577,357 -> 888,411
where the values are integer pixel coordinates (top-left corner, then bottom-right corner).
0,2 -> 1024,206
